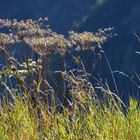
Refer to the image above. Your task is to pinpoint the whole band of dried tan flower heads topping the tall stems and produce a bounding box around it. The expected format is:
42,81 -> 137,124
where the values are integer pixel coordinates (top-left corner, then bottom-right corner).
0,18 -> 111,56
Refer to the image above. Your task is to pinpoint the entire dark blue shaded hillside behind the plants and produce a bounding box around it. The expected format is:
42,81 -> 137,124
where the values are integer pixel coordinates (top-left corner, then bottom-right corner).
0,0 -> 140,103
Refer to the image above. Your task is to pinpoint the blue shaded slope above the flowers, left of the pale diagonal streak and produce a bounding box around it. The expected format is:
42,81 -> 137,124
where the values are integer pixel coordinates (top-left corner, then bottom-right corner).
0,0 -> 95,33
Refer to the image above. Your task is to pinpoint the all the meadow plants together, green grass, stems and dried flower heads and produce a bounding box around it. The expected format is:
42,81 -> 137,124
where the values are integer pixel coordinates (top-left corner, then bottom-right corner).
0,18 -> 140,140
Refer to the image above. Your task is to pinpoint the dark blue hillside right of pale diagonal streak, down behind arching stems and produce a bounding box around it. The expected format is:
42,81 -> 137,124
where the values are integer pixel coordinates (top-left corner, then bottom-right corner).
77,0 -> 140,98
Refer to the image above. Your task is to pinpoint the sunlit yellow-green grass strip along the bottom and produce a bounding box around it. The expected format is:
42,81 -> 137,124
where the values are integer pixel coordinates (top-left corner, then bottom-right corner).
0,94 -> 140,140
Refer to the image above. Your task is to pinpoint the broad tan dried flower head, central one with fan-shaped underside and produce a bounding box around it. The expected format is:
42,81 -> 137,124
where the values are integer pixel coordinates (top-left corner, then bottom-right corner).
24,34 -> 70,56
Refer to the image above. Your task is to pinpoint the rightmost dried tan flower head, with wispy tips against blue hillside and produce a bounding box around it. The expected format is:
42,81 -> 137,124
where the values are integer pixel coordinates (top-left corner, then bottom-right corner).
69,28 -> 112,51
